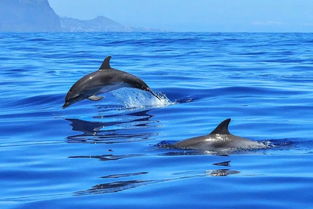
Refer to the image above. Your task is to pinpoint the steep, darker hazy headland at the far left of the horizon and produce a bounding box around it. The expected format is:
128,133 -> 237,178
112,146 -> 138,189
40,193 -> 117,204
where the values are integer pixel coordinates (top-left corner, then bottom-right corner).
0,0 -> 61,32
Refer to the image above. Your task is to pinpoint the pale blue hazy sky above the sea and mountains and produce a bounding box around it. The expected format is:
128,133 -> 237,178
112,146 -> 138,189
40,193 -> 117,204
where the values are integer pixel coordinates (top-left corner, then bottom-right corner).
49,0 -> 313,32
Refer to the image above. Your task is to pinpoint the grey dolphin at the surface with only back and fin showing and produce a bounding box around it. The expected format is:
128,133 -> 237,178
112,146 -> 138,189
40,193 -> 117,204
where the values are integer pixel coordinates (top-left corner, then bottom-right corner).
173,118 -> 267,152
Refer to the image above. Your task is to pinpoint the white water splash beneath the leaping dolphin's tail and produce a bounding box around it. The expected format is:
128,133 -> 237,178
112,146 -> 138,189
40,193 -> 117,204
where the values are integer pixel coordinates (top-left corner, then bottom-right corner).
112,88 -> 174,108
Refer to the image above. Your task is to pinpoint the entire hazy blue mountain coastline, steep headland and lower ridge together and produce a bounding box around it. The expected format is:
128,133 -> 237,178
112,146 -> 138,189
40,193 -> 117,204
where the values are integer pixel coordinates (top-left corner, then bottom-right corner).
0,0 -> 157,32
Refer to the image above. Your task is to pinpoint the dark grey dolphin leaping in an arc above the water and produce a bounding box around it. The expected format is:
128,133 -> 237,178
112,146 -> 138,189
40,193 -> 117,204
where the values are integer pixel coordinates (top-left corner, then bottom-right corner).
63,56 -> 160,108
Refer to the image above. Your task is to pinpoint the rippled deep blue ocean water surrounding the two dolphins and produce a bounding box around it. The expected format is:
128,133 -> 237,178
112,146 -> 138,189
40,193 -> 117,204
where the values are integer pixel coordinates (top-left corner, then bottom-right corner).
0,33 -> 313,209
